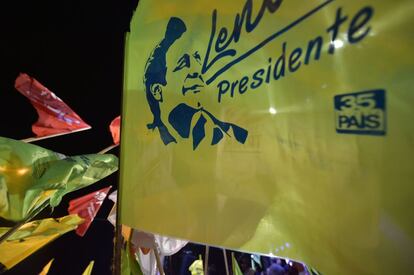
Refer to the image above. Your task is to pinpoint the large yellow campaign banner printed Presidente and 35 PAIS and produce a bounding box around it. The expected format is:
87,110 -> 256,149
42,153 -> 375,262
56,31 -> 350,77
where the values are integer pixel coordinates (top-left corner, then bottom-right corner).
121,0 -> 414,274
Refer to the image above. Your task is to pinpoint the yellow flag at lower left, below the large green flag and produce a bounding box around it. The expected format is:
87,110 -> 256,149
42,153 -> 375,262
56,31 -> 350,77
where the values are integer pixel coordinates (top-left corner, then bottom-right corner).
0,215 -> 83,269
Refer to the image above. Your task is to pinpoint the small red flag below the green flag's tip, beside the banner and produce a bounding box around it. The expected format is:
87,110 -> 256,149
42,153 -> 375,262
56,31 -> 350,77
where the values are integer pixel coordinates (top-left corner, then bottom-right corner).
68,186 -> 112,237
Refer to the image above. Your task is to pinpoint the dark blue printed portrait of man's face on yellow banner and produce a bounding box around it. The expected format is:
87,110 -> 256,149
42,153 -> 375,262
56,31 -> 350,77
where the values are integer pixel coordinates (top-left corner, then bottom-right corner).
143,17 -> 248,150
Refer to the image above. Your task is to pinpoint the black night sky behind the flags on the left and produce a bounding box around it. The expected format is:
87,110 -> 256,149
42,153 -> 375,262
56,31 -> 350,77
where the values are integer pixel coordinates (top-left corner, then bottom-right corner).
0,0 -> 137,274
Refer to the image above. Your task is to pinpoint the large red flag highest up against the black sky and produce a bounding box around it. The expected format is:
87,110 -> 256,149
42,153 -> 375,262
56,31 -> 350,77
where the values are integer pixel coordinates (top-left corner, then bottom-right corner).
14,74 -> 91,137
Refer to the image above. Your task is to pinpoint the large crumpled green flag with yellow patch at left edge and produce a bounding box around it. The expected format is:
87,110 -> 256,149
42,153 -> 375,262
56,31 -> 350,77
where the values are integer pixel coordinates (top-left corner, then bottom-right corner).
0,137 -> 118,221
